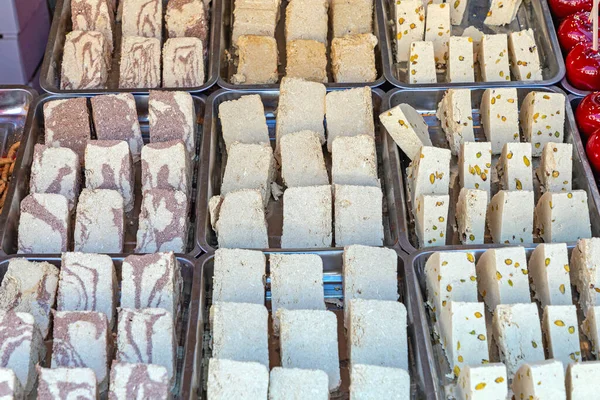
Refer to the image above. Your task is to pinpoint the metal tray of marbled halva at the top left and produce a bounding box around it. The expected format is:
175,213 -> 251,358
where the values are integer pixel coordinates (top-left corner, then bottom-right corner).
40,0 -> 221,94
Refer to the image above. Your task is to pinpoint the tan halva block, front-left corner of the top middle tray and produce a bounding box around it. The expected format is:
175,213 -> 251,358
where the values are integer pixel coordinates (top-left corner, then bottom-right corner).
231,35 -> 279,85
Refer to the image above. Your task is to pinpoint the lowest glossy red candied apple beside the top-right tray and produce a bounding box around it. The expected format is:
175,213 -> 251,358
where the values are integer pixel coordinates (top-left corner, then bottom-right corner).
566,43 -> 600,90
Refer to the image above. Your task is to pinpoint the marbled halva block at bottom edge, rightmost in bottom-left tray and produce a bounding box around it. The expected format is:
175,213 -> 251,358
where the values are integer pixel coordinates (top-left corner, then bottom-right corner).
108,362 -> 170,400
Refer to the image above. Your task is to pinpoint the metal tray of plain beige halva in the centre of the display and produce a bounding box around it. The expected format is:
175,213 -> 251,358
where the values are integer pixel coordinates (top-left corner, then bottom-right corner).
196,89 -> 401,253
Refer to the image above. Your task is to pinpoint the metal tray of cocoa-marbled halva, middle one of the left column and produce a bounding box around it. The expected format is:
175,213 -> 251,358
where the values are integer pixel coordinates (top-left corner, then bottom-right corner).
0,95 -> 206,257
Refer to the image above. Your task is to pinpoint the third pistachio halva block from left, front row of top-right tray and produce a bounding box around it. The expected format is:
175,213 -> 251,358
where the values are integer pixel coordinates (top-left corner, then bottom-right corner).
479,33 -> 516,83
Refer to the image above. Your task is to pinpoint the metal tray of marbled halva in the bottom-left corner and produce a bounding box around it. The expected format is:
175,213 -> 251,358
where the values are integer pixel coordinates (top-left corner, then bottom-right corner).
0,254 -> 202,400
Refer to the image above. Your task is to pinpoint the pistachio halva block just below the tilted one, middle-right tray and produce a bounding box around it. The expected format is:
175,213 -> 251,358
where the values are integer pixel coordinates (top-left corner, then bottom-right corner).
407,146 -> 451,210
